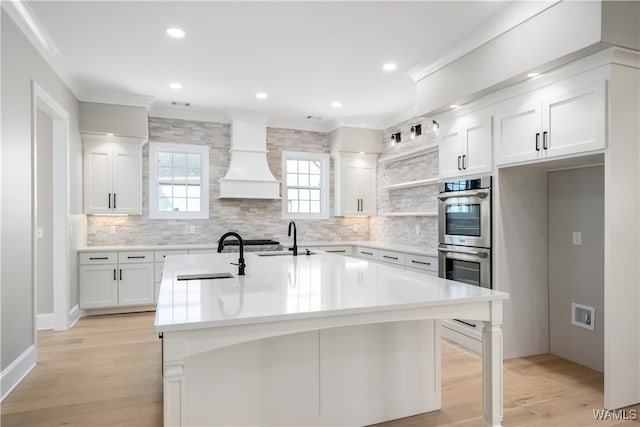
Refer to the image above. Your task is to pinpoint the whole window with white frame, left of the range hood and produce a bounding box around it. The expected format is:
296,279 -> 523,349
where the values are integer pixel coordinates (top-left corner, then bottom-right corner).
149,142 -> 209,219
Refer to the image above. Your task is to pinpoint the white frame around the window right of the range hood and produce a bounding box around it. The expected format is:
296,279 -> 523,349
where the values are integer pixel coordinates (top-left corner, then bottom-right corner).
282,151 -> 331,219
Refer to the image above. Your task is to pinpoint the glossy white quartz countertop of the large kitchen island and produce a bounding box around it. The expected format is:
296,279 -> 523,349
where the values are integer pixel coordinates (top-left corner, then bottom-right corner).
155,251 -> 508,332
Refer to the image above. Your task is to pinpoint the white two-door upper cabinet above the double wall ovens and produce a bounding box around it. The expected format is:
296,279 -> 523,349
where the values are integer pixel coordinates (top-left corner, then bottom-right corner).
438,112 -> 493,178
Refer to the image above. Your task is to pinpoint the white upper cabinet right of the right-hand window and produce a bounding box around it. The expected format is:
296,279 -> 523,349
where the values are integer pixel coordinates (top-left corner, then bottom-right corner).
334,153 -> 378,216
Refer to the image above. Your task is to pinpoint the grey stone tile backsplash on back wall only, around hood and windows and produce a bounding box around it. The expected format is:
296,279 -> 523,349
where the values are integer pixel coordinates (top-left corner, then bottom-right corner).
87,117 -> 369,246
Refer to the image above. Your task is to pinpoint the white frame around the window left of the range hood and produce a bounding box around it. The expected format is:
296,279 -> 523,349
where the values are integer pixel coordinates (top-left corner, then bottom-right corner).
149,142 -> 209,219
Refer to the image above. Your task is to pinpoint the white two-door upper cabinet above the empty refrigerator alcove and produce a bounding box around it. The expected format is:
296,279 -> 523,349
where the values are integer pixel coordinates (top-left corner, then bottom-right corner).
494,80 -> 606,165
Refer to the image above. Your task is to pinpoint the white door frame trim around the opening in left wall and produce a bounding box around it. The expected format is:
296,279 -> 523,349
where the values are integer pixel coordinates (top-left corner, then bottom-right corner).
31,81 -> 71,334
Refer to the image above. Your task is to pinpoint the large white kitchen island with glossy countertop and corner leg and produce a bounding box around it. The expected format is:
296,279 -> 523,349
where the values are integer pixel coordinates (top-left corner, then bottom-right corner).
155,252 -> 507,426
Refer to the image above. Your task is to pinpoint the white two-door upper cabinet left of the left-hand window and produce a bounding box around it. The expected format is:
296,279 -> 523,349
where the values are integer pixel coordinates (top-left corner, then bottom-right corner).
84,136 -> 142,215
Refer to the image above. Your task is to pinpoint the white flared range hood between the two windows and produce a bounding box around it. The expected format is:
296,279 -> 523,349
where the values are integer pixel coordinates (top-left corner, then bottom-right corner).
219,119 -> 280,199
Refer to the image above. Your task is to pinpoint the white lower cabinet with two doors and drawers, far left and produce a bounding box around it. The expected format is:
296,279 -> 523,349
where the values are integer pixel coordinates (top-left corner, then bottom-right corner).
79,251 -> 155,309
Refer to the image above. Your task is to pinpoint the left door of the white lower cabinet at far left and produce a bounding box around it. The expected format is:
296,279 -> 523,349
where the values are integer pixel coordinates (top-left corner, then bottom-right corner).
80,264 -> 118,309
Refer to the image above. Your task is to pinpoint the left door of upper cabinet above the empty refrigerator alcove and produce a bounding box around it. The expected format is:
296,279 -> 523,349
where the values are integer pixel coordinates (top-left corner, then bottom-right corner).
493,94 -> 542,165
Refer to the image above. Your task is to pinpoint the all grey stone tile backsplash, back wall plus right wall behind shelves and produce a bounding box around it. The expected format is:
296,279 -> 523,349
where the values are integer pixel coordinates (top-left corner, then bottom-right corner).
87,116 -> 438,250
